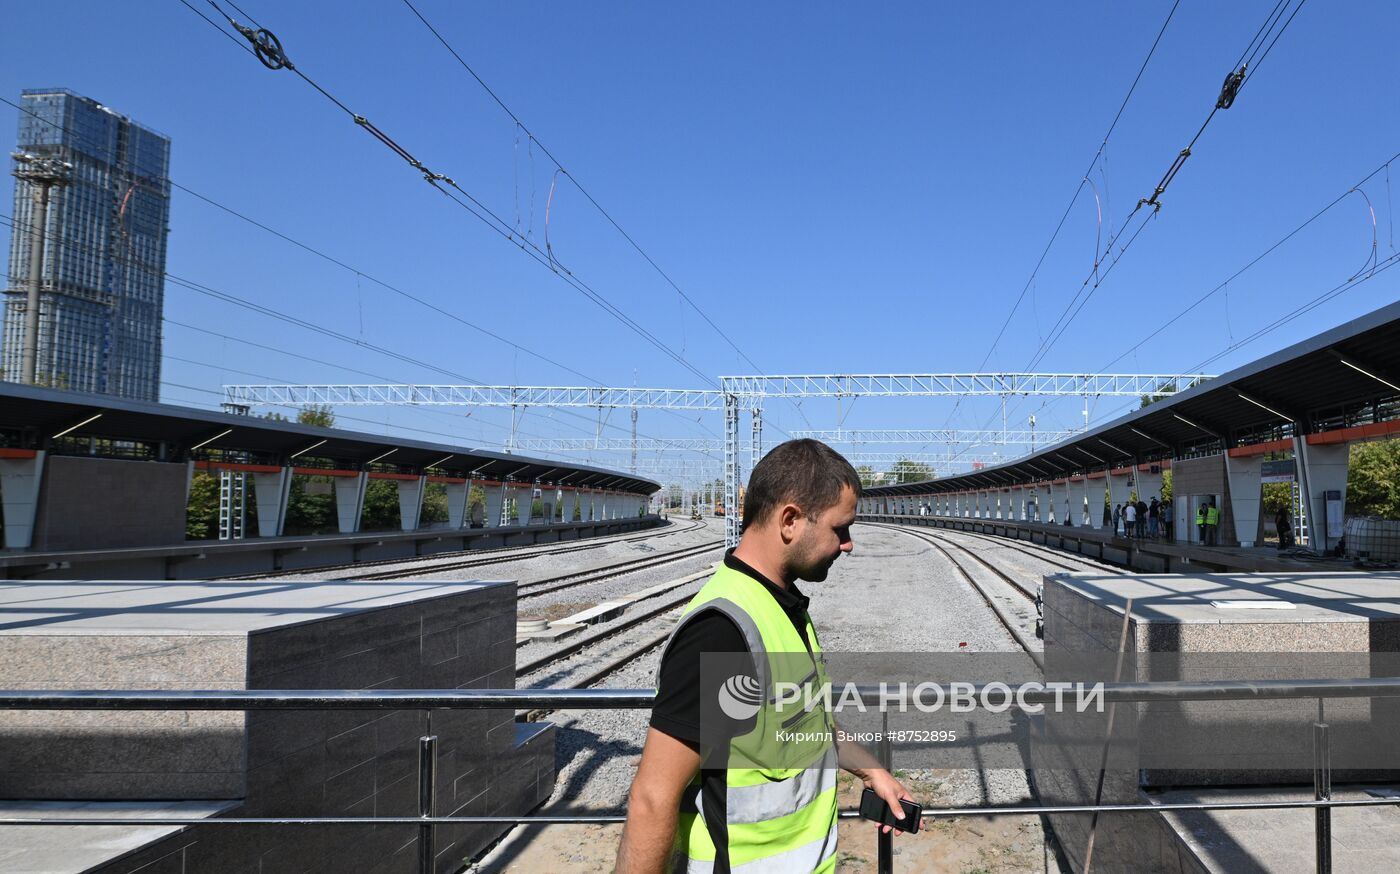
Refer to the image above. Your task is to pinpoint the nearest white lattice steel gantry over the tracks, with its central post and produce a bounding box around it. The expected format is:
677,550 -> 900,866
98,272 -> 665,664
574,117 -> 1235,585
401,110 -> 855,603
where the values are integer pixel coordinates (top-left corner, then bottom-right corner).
224,373 -> 1211,546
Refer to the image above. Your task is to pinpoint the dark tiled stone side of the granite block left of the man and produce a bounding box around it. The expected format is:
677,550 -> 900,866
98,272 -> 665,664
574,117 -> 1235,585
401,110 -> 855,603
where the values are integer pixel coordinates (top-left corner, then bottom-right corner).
58,584 -> 554,874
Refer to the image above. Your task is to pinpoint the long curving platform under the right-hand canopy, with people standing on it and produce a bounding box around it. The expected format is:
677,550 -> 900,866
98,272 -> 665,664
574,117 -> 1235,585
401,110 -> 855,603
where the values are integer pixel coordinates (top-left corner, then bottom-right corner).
858,514 -> 1355,573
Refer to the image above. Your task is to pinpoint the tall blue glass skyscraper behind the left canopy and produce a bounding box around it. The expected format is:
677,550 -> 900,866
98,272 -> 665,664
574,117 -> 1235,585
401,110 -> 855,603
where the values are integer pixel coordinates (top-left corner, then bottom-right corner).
0,88 -> 171,401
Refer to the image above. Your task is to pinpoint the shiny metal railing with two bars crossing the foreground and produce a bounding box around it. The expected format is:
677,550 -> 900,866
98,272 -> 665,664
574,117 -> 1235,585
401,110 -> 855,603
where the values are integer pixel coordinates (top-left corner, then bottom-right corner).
0,677 -> 1400,874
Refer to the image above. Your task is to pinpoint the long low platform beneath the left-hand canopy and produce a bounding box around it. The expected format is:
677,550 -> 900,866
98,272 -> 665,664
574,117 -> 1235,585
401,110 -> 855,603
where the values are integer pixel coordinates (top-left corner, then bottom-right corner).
0,515 -> 664,580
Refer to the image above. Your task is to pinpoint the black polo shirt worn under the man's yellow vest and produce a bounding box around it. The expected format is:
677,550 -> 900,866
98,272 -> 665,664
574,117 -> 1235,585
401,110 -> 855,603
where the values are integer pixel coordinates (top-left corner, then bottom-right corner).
651,549 -> 812,744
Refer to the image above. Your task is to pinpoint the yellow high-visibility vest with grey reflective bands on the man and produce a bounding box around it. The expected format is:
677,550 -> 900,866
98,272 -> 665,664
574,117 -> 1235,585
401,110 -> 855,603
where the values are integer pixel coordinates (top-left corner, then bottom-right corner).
668,564 -> 836,874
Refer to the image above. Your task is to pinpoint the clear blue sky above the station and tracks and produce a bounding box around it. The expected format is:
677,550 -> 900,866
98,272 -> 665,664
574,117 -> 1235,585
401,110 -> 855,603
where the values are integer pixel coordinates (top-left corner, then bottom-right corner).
0,0 -> 1400,479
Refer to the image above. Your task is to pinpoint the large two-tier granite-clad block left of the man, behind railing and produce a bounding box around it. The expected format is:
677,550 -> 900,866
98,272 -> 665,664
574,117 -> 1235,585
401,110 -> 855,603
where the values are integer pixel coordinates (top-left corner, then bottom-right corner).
0,580 -> 556,874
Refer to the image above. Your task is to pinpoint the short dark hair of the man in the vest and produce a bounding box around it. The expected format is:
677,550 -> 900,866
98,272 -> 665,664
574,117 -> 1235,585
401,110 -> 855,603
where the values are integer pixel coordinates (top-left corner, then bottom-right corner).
743,440 -> 861,528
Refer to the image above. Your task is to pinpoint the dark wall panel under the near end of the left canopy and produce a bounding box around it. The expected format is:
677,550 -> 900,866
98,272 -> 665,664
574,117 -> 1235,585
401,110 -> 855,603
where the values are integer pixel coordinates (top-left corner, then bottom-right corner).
32,455 -> 189,552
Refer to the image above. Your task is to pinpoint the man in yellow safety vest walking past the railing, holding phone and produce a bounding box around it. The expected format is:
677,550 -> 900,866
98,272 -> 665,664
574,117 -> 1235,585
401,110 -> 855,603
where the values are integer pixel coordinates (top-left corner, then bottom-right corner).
616,440 -> 913,874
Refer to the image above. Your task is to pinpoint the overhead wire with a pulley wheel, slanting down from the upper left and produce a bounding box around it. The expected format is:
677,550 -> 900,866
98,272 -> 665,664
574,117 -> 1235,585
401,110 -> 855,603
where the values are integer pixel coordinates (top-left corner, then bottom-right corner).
184,0 -> 715,385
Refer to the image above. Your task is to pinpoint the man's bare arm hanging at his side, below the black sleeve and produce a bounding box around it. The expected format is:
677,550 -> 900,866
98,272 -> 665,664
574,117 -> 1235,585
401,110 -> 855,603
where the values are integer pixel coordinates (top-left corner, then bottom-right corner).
615,728 -> 700,874
